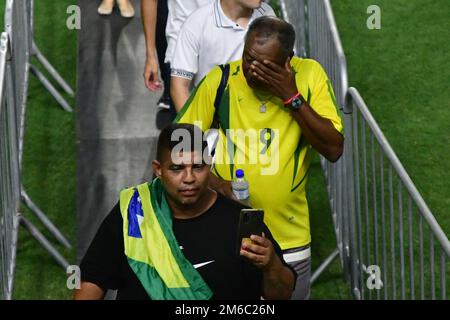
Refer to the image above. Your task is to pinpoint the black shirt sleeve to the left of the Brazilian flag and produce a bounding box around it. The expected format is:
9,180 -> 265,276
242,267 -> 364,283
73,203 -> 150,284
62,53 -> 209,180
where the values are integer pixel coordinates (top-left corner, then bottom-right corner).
80,204 -> 125,291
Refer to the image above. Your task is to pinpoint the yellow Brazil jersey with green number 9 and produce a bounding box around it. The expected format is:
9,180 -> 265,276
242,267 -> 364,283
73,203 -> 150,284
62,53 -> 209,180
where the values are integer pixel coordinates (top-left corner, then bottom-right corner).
175,57 -> 343,249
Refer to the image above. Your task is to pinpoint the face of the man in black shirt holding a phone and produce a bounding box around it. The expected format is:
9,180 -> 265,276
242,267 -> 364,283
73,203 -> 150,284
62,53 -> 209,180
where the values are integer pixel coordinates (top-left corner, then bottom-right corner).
152,150 -> 210,207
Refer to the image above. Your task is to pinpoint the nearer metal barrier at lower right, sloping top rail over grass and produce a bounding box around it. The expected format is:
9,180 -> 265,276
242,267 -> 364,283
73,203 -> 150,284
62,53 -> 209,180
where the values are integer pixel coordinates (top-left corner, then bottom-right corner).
346,88 -> 450,300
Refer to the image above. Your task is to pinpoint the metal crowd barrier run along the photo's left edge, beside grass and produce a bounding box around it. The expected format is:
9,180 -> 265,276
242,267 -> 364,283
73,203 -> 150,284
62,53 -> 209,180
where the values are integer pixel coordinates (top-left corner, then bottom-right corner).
0,0 -> 70,299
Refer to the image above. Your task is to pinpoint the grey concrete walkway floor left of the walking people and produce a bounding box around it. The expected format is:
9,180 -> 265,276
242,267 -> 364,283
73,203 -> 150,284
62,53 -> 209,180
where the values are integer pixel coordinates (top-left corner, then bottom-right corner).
76,0 -> 170,261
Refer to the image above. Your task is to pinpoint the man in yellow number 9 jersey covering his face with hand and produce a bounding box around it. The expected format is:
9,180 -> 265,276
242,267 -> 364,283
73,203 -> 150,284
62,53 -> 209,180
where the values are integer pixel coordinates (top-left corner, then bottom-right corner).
176,17 -> 344,299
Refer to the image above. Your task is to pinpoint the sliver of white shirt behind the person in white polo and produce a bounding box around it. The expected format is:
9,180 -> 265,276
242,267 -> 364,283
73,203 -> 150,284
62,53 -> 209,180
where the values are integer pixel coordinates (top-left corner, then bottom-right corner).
164,0 -> 214,63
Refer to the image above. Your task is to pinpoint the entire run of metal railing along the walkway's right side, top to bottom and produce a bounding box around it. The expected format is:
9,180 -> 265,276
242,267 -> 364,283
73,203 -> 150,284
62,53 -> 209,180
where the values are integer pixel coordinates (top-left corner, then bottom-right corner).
280,0 -> 450,299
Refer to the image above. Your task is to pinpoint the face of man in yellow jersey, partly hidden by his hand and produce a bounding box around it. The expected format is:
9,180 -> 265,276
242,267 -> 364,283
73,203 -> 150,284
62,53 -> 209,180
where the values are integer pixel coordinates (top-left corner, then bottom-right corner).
242,33 -> 285,91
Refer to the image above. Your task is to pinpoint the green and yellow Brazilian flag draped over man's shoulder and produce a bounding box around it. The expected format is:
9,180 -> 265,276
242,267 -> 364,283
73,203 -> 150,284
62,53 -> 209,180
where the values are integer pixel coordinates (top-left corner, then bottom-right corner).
120,179 -> 212,300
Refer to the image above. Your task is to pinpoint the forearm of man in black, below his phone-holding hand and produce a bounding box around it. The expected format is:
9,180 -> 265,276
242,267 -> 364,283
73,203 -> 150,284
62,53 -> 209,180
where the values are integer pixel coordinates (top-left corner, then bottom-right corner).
263,257 -> 295,300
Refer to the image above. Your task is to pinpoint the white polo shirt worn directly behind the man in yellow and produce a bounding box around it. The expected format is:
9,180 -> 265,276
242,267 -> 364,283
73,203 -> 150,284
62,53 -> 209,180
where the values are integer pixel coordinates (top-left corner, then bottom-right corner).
171,0 -> 275,85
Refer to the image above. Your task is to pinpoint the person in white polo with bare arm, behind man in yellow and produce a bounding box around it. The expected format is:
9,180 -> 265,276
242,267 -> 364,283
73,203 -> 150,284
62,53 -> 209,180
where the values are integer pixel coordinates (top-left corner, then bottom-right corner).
170,0 -> 275,111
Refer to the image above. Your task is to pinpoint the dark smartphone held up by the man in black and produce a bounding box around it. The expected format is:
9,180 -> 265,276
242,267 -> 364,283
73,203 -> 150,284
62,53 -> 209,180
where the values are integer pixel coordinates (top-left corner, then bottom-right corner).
236,209 -> 264,256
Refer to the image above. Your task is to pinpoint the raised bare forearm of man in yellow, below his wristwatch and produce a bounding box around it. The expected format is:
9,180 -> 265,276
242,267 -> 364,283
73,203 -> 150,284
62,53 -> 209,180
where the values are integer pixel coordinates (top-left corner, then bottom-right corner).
291,102 -> 344,162
